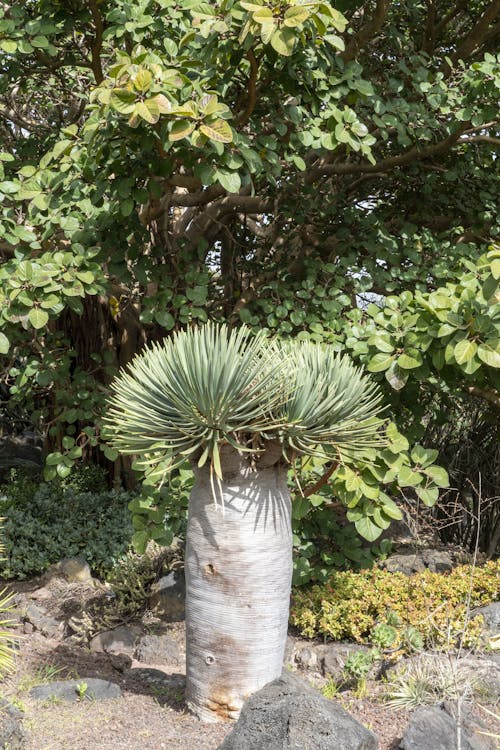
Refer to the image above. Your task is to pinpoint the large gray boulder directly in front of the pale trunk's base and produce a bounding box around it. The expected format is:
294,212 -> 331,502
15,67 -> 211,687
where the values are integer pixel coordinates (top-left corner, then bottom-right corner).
219,672 -> 378,750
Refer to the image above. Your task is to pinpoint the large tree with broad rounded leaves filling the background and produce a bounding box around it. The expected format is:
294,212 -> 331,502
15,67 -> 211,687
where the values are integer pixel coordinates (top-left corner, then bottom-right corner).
0,5 -> 499,539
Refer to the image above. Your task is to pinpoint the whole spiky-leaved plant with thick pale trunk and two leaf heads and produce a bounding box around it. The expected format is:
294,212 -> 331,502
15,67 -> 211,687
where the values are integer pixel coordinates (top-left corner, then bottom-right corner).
106,323 -> 382,720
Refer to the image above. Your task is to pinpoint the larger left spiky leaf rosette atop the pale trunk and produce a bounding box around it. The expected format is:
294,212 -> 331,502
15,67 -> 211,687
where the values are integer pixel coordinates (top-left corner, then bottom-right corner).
105,323 -> 287,476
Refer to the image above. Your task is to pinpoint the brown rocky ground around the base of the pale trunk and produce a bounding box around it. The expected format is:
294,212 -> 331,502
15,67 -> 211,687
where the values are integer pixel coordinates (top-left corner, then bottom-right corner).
0,574 -> 500,750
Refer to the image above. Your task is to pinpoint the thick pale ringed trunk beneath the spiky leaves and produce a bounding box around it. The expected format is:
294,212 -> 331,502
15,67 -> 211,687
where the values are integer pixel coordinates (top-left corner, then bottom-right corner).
186,451 -> 292,721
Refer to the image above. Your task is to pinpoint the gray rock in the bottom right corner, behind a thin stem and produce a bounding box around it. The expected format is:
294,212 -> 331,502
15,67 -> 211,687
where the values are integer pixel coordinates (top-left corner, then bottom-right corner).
399,704 -> 495,750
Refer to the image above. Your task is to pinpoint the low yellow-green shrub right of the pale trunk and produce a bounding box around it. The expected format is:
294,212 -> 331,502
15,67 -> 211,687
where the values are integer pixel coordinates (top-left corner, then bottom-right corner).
290,560 -> 500,647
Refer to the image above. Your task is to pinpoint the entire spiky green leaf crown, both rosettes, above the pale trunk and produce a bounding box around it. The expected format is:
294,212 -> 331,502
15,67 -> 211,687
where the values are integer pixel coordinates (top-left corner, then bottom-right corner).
105,323 -> 383,478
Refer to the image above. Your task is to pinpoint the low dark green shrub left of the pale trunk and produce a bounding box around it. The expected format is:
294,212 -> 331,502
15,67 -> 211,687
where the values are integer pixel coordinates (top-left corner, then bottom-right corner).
0,472 -> 133,579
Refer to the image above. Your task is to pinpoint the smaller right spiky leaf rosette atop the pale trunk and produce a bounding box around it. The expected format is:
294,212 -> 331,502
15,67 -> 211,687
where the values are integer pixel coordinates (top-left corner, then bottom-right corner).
276,341 -> 384,456
